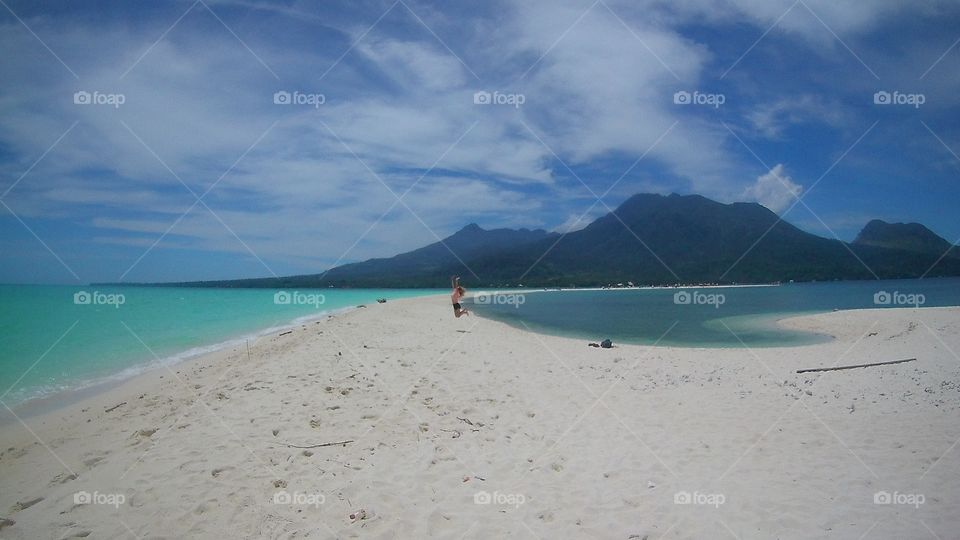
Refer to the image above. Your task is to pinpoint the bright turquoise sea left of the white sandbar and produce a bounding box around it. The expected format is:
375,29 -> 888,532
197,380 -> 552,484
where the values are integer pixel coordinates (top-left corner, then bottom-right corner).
0,285 -> 447,406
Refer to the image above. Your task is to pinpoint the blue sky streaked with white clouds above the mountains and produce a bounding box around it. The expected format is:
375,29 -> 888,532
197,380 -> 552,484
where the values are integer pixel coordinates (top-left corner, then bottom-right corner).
0,0 -> 960,283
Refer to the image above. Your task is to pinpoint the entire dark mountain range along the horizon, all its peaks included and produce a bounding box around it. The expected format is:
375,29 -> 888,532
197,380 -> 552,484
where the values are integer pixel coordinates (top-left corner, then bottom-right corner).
116,194 -> 960,288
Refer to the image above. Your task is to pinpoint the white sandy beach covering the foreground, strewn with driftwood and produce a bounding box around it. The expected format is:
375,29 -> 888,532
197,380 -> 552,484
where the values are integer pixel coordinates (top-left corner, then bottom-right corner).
0,297 -> 960,540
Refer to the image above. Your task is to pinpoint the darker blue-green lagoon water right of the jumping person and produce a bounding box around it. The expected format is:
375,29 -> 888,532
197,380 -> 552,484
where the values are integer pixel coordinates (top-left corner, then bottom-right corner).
469,278 -> 960,347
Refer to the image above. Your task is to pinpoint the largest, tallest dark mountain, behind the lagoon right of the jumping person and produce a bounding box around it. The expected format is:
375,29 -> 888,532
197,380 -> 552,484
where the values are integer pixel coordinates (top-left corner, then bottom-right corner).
458,194 -> 960,285
